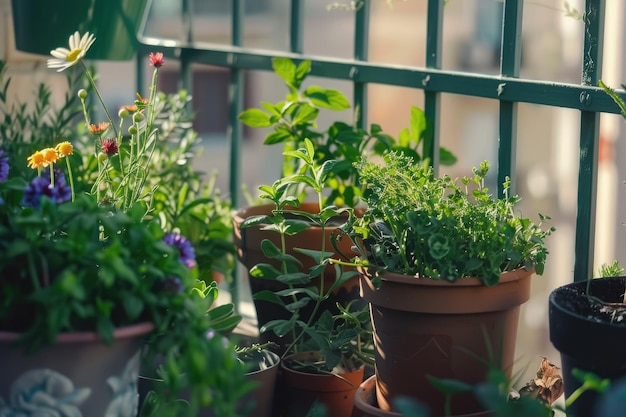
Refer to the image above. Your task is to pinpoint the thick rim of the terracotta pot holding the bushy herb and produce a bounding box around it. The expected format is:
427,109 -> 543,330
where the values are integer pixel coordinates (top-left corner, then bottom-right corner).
359,268 -> 534,314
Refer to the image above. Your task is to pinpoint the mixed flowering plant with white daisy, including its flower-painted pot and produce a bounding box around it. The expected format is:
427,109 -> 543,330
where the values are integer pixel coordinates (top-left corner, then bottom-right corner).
0,33 -> 249,416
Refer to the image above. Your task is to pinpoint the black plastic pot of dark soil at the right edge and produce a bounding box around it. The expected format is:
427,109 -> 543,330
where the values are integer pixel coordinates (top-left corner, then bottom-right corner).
549,277 -> 626,417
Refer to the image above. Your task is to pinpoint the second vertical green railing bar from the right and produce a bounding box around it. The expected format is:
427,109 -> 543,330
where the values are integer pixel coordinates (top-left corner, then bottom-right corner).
498,0 -> 524,197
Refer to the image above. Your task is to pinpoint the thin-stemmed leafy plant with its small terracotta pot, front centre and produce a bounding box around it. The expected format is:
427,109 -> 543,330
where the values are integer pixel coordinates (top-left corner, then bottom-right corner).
242,141 -> 371,417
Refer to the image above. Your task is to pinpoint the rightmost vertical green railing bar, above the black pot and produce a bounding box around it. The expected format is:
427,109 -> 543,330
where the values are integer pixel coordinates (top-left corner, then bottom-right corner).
574,0 -> 605,281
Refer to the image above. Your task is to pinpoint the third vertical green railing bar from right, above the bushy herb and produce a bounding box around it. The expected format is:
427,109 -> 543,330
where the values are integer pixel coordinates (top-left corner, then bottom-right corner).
422,0 -> 444,173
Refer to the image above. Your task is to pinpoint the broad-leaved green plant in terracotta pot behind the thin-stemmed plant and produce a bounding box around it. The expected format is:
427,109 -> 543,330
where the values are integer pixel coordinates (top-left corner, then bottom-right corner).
233,58 -> 455,338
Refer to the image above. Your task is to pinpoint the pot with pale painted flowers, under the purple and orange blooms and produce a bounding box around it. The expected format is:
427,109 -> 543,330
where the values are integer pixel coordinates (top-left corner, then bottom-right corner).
0,323 -> 154,417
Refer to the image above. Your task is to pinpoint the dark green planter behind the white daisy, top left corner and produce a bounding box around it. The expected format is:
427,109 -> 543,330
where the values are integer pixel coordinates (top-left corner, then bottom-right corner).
12,0 -> 151,60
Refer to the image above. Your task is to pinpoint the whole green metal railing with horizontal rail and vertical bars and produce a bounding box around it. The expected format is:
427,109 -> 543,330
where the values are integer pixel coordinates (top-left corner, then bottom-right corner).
140,0 -> 618,306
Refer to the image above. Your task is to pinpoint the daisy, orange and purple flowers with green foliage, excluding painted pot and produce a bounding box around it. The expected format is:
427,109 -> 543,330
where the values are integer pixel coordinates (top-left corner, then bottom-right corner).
0,33 -> 245,416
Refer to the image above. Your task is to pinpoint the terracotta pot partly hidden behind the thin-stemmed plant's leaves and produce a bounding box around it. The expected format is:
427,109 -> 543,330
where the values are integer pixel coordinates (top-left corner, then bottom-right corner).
233,203 -> 359,345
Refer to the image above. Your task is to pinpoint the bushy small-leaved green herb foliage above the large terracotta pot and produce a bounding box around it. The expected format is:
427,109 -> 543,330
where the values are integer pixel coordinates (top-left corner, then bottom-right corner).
344,152 -> 554,285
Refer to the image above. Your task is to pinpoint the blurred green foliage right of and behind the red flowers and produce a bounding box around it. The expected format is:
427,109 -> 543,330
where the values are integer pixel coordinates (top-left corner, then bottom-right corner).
146,90 -> 236,283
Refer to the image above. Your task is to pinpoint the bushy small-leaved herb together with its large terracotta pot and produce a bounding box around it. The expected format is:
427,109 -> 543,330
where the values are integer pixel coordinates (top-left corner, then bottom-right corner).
338,152 -> 552,415
